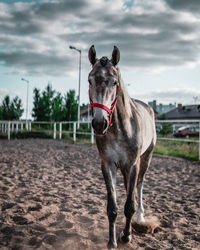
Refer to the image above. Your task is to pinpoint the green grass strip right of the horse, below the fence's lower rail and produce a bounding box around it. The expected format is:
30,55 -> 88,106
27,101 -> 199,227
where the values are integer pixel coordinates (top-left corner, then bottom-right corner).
154,141 -> 198,161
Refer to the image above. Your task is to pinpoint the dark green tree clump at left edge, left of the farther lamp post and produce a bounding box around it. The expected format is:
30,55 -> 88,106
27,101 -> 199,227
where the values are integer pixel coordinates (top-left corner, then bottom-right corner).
0,95 -> 24,120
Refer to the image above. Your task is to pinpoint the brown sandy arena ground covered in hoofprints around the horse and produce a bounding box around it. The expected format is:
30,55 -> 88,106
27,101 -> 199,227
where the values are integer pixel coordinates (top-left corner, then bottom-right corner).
0,139 -> 200,250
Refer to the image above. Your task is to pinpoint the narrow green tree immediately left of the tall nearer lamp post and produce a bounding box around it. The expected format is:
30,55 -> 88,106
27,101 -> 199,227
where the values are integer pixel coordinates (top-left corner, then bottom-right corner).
64,90 -> 78,121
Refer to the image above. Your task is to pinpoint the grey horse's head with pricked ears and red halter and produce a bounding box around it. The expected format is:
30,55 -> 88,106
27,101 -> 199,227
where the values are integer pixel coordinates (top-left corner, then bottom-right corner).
88,45 -> 120,135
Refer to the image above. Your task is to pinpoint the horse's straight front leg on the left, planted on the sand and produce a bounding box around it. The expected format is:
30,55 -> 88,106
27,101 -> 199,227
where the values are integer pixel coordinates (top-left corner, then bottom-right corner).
101,164 -> 117,249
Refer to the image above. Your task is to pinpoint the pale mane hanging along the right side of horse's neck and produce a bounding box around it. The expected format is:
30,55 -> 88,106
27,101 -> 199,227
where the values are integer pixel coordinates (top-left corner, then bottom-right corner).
117,68 -> 135,118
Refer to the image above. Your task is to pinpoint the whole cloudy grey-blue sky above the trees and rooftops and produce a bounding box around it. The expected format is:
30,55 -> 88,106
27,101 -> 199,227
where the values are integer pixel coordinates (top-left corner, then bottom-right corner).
0,0 -> 200,117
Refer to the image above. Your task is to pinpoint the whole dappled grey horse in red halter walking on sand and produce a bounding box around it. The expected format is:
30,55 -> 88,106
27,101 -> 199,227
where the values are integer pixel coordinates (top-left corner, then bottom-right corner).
88,45 -> 156,249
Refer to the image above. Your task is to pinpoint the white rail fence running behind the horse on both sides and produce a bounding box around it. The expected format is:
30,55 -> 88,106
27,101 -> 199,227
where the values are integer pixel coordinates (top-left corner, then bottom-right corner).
0,120 -> 200,160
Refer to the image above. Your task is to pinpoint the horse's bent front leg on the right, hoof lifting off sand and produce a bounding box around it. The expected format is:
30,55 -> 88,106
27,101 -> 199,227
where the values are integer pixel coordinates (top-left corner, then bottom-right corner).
120,164 -> 138,243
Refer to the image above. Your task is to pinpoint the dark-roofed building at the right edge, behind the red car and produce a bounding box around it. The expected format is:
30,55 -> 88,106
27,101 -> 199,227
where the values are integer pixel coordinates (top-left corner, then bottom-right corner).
159,104 -> 200,120
